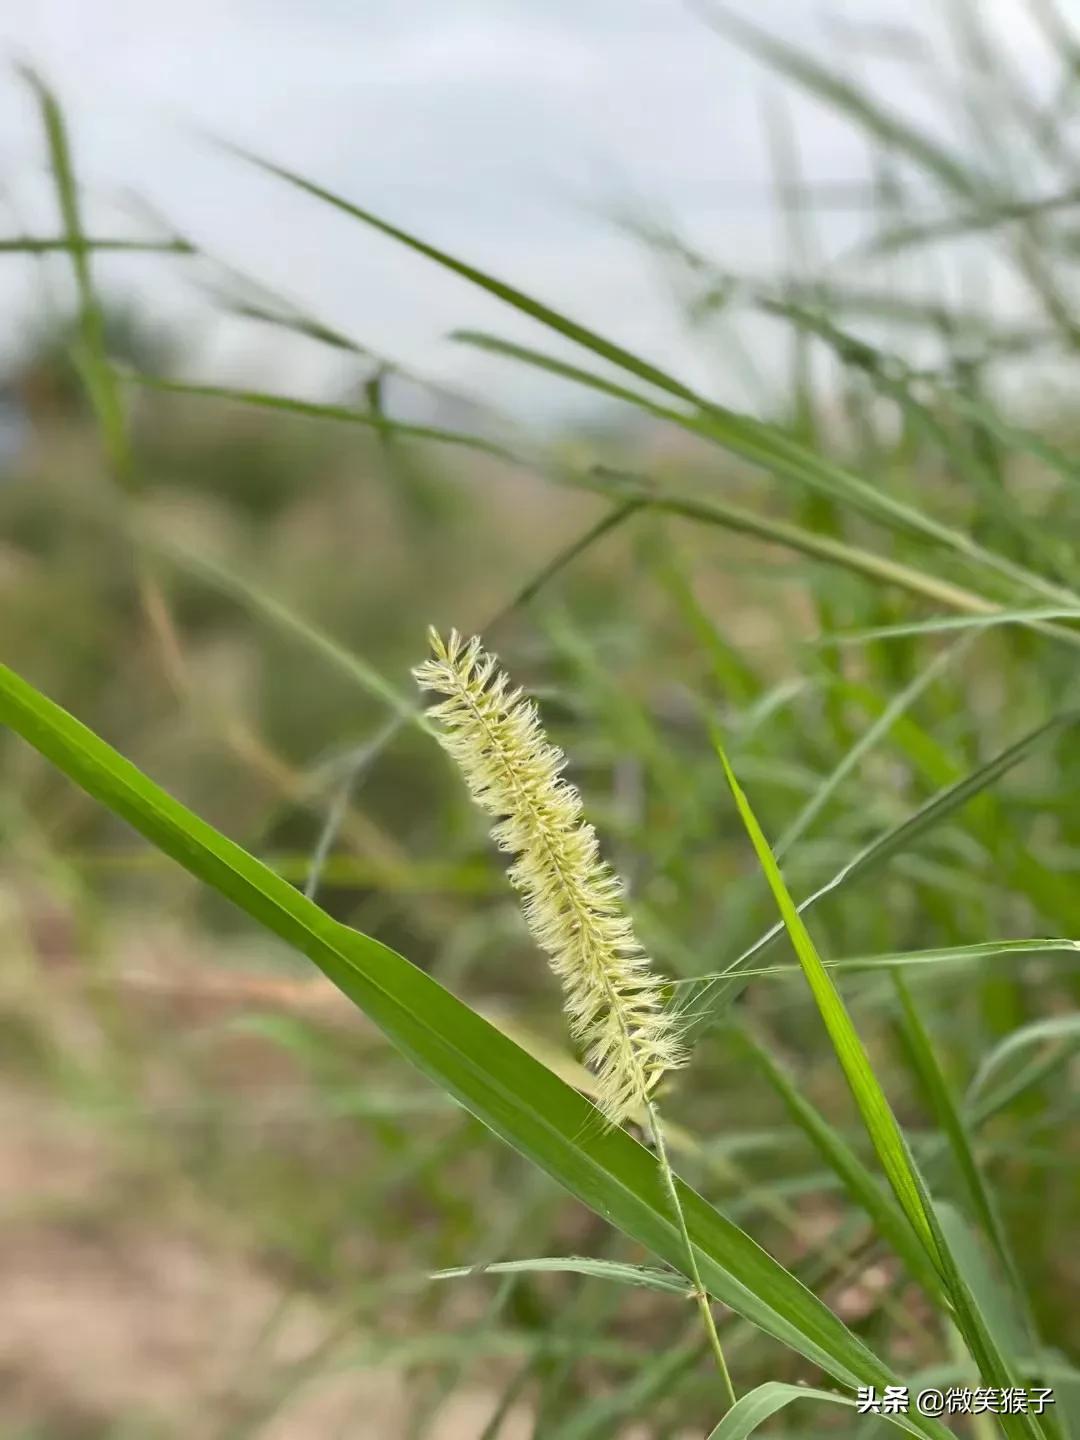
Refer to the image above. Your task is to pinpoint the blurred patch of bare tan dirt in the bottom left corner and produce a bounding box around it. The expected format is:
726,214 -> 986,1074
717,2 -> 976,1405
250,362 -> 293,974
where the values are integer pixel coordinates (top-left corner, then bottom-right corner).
0,1094 -> 541,1440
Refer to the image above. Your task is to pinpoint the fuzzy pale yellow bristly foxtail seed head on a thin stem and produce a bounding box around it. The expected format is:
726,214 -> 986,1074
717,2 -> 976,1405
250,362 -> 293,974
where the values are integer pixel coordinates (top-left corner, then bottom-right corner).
413,629 -> 685,1125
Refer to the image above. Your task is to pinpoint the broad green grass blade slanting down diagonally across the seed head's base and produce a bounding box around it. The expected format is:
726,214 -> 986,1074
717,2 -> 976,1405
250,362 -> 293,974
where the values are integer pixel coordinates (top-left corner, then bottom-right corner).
0,665 -> 948,1440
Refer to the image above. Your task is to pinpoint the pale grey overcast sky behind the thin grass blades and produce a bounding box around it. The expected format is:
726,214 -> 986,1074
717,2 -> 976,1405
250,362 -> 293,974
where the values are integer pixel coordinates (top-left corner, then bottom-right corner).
0,0 -> 1059,412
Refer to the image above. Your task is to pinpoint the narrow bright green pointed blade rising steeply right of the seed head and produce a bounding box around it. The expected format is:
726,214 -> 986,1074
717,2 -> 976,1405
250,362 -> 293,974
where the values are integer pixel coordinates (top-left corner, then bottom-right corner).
713,730 -> 1043,1437
